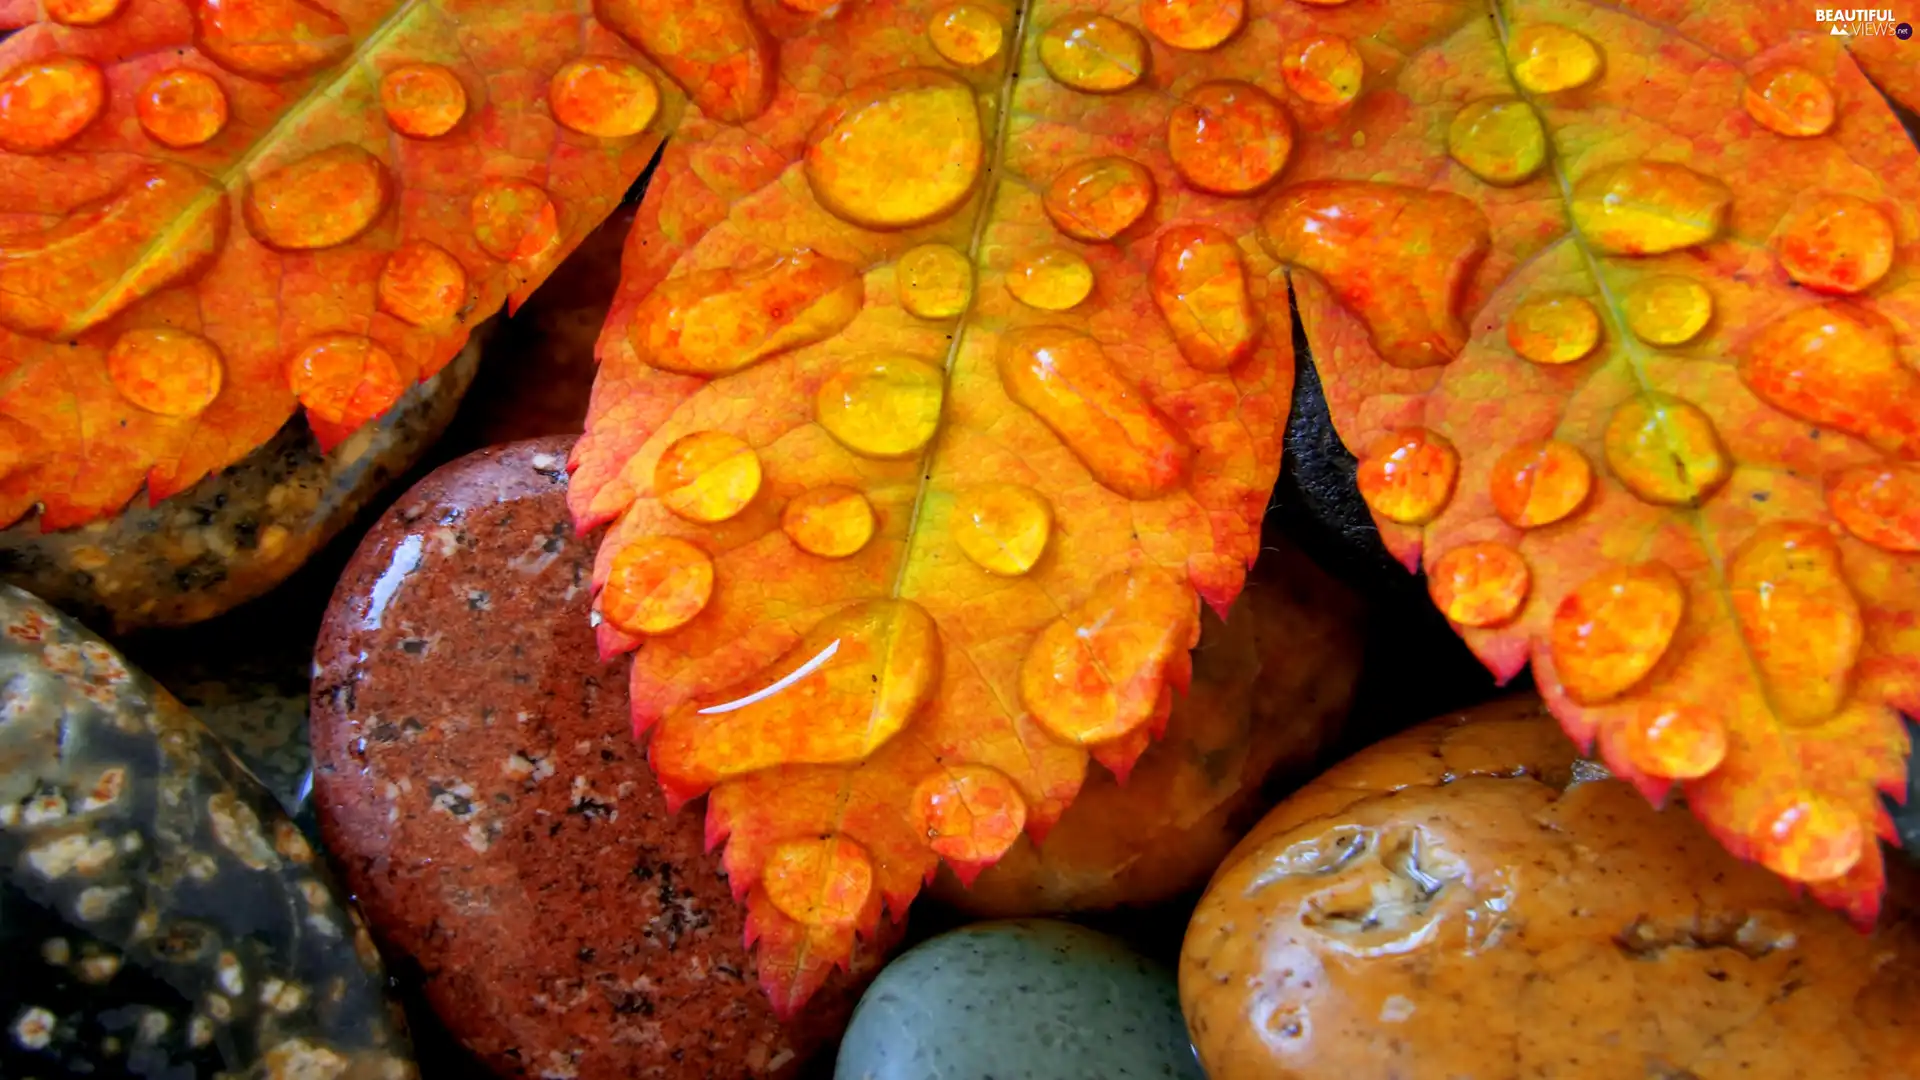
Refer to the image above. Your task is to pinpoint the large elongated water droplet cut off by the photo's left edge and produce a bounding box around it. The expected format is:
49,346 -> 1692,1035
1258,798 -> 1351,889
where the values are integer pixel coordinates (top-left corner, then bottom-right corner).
0,161 -> 230,338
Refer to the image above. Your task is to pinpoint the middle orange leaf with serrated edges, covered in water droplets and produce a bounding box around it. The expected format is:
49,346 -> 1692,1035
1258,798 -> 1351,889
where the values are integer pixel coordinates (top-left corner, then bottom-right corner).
572,0 -> 1292,1009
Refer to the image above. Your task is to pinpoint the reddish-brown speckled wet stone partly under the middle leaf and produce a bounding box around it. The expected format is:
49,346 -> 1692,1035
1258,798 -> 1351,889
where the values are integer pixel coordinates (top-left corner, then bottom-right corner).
313,438 -> 877,1080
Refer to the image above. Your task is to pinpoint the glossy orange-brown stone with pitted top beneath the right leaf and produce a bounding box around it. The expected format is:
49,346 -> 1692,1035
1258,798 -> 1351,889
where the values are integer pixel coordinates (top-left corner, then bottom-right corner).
1181,698 -> 1920,1080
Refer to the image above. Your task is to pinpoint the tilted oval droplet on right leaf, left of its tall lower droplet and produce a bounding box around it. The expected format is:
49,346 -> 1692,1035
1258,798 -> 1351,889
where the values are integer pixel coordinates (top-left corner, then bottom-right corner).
1551,563 -> 1686,705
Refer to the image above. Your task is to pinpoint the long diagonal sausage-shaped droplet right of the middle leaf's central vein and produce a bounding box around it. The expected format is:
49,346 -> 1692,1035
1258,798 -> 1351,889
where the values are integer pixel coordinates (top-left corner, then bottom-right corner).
998,327 -> 1190,500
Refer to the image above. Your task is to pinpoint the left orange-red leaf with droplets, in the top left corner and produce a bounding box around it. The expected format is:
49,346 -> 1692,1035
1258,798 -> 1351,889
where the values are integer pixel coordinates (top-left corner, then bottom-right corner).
0,0 -> 684,528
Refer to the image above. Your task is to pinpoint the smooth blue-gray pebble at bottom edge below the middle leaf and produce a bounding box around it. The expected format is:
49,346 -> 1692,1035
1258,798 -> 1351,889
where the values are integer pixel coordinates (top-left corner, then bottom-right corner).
833,919 -> 1204,1080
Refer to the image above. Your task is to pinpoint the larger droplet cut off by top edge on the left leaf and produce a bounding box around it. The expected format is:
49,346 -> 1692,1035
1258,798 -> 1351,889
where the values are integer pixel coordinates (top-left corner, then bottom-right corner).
194,0 -> 353,81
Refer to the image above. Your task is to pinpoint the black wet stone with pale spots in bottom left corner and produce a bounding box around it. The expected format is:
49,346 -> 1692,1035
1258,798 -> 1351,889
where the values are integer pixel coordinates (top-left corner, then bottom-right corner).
0,586 -> 415,1080
